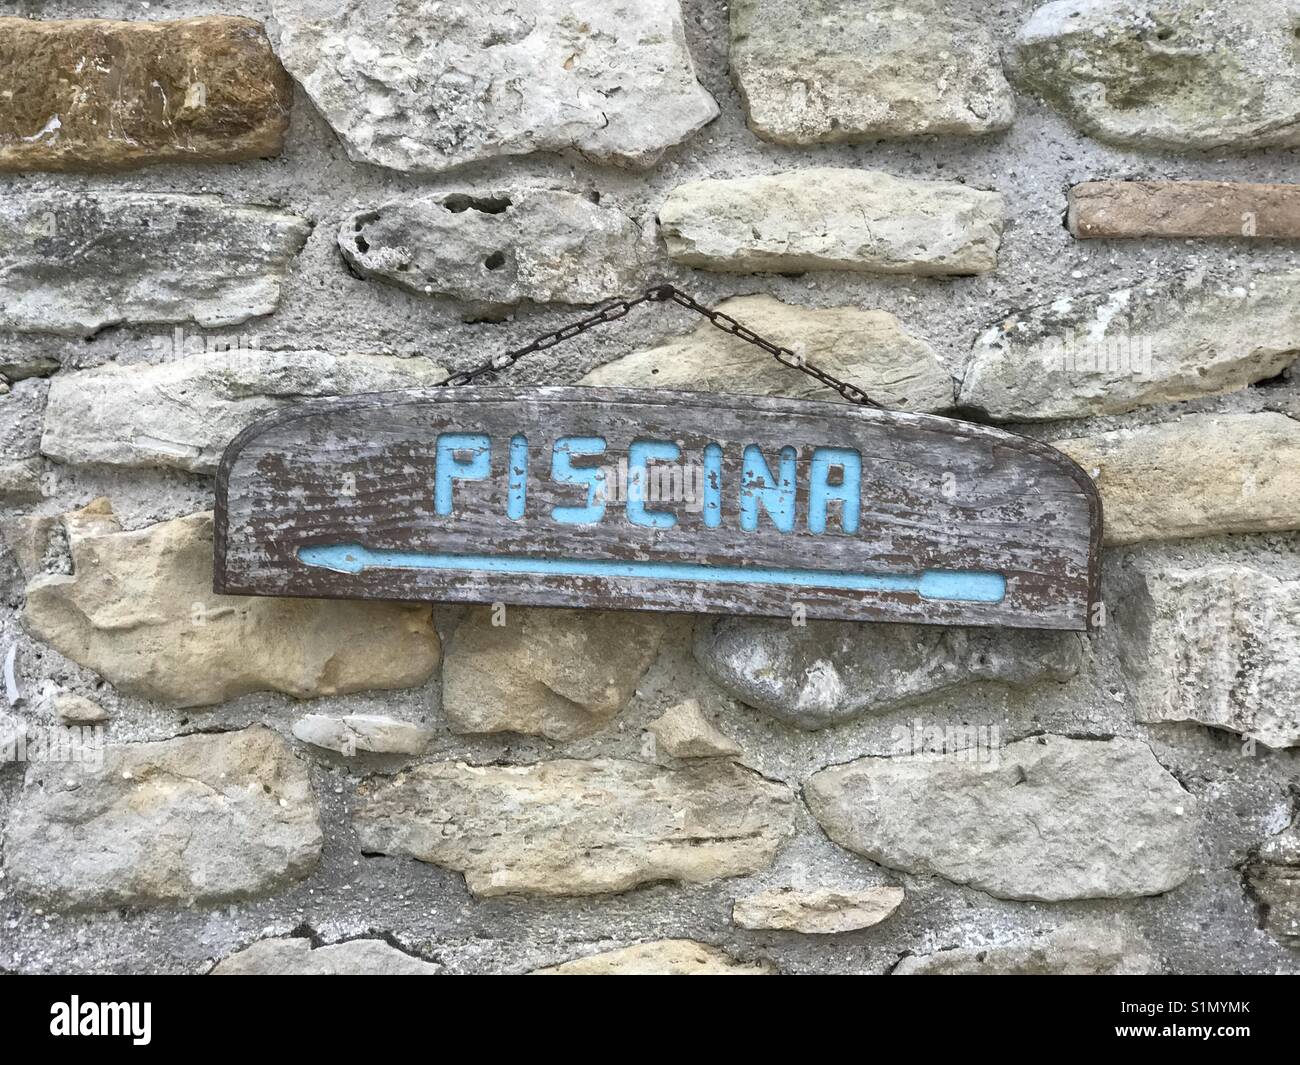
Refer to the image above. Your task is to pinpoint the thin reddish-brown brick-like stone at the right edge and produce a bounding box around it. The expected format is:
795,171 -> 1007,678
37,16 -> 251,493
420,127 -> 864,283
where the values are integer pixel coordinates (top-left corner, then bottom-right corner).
1066,181 -> 1300,241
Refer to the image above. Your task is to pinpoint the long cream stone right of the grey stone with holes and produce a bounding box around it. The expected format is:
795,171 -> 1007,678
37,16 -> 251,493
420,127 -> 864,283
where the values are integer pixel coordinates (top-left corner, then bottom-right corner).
659,168 -> 1002,277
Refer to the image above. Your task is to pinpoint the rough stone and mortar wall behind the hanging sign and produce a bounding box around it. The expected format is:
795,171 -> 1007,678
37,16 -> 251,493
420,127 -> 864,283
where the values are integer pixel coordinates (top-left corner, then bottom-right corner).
0,0 -> 1300,974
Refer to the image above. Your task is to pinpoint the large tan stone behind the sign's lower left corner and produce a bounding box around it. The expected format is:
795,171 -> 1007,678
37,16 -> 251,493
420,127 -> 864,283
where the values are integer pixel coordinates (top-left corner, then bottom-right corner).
23,499 -> 438,706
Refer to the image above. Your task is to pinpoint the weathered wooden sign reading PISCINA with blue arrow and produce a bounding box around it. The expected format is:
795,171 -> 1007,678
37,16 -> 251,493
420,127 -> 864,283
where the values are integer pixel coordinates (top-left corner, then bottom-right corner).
216,386 -> 1101,629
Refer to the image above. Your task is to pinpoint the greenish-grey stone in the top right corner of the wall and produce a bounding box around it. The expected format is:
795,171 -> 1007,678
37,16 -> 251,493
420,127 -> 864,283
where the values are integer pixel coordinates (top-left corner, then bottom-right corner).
1009,0 -> 1300,152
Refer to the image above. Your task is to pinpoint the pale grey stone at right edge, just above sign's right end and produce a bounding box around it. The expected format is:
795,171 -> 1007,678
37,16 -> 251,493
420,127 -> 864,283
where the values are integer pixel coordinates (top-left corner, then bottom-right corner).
958,273 -> 1300,421
